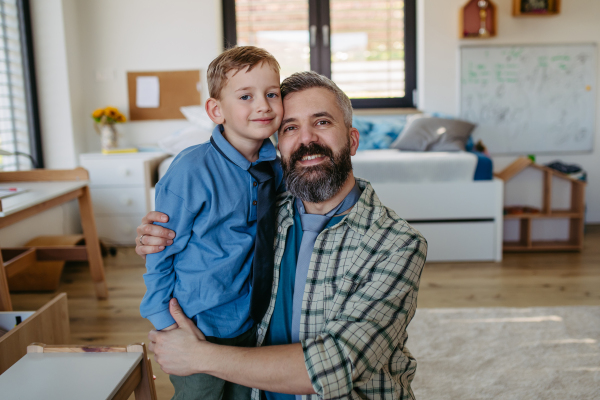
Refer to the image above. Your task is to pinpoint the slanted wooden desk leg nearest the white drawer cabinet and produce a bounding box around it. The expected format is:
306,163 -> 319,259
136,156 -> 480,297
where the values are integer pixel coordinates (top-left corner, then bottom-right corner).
78,186 -> 108,299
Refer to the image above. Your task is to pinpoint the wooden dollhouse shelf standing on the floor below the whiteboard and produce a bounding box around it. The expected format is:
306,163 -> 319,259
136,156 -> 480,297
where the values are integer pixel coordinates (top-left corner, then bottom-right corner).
496,157 -> 586,252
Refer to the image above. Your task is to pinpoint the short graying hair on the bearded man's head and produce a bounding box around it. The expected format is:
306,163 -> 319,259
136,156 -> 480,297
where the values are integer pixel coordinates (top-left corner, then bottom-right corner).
281,71 -> 352,128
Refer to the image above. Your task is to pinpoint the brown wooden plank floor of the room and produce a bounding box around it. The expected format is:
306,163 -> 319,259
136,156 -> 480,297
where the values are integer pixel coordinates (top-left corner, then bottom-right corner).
12,225 -> 600,399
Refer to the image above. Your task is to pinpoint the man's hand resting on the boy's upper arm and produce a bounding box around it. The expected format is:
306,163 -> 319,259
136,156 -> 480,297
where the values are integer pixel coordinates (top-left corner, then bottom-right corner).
135,211 -> 175,259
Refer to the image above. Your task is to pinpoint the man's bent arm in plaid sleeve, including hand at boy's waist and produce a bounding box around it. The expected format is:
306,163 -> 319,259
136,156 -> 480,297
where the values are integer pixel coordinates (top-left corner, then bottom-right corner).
148,237 -> 427,399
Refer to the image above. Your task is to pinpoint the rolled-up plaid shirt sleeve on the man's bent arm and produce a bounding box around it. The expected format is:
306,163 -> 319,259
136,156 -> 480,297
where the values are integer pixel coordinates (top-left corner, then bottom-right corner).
301,236 -> 427,399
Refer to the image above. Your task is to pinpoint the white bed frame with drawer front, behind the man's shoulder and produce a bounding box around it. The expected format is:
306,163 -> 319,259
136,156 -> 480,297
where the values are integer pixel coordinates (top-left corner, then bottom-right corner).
372,178 -> 504,261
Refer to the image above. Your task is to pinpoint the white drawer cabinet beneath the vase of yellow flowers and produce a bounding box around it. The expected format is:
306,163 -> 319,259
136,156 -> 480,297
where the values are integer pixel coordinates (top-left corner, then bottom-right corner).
79,152 -> 168,246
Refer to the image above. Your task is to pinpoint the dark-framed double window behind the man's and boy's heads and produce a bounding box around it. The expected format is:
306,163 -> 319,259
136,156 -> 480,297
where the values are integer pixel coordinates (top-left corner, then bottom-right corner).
223,0 -> 416,108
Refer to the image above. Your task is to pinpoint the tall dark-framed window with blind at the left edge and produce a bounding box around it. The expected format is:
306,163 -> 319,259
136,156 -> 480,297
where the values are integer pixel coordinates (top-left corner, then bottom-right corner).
0,0 -> 43,171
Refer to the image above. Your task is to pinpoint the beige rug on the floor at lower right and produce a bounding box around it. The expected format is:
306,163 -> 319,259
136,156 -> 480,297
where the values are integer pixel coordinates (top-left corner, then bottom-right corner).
407,306 -> 600,400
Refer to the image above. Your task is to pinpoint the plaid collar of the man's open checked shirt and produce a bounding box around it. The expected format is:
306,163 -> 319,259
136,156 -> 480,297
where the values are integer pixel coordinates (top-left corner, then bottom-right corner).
277,177 -> 385,235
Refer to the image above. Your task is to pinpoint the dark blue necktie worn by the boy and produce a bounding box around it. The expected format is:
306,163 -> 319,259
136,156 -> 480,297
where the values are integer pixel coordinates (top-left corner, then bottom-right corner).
210,137 -> 277,323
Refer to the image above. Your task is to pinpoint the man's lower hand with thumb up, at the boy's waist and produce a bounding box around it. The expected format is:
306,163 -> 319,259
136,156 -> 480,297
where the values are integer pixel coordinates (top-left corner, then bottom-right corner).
148,299 -> 213,376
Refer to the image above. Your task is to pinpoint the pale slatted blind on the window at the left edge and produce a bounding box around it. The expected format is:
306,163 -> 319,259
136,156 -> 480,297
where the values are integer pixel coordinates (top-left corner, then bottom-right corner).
0,0 -> 32,171
